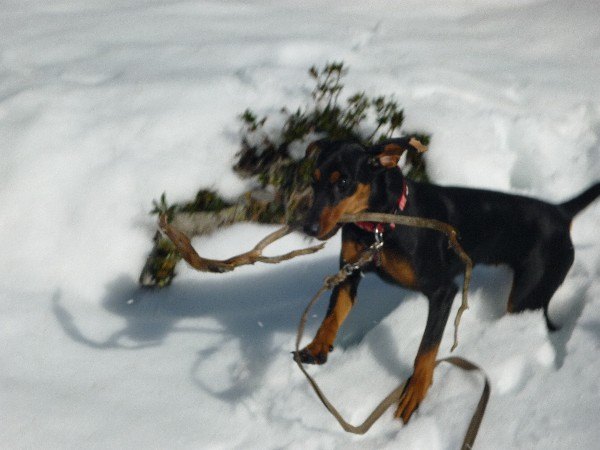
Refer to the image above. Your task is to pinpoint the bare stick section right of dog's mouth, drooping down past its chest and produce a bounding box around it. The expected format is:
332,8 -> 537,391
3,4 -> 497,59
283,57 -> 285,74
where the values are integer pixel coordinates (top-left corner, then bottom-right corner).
340,213 -> 473,351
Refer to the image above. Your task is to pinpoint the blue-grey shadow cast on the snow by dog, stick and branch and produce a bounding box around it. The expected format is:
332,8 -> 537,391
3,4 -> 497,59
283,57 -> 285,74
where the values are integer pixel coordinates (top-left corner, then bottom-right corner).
53,258 -> 582,401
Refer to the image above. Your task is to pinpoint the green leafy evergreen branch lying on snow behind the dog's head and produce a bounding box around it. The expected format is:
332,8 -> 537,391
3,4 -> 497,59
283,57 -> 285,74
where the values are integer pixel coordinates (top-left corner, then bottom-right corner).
139,62 -> 429,287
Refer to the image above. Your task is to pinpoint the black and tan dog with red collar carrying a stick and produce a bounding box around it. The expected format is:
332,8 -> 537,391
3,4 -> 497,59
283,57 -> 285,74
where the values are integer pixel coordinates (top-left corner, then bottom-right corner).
297,137 -> 600,422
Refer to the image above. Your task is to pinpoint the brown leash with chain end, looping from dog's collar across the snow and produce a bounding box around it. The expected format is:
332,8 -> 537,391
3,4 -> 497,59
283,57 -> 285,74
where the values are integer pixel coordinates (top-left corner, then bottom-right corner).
294,243 -> 491,450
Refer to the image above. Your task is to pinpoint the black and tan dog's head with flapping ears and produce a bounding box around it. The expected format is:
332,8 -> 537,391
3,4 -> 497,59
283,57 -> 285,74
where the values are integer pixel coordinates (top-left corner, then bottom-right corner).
304,137 -> 426,240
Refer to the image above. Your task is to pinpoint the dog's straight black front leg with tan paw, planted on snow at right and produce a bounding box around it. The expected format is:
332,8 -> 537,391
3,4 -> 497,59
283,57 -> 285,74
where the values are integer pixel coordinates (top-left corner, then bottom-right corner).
395,283 -> 458,423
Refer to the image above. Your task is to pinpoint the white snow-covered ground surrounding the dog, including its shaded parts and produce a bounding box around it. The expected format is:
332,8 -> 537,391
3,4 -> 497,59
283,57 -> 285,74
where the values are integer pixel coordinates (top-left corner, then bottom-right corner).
0,0 -> 600,449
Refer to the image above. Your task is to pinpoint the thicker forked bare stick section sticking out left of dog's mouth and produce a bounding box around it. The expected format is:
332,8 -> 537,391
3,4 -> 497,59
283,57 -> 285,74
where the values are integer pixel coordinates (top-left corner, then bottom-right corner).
159,214 -> 325,273
